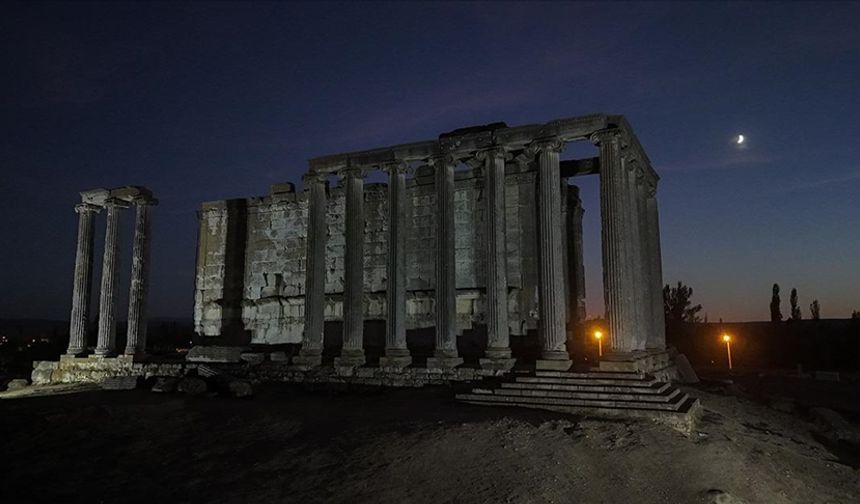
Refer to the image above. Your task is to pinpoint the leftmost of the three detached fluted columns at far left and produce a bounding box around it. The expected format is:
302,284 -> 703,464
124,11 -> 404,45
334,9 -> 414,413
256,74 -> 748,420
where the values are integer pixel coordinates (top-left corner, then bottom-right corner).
66,203 -> 100,355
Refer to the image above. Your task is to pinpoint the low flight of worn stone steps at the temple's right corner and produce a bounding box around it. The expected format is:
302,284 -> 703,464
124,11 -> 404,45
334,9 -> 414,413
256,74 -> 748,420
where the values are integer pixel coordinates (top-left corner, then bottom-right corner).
456,371 -> 702,434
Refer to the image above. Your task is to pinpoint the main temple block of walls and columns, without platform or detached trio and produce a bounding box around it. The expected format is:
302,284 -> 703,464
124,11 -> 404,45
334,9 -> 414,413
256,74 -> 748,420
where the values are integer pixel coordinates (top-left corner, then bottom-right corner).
194,115 -> 665,369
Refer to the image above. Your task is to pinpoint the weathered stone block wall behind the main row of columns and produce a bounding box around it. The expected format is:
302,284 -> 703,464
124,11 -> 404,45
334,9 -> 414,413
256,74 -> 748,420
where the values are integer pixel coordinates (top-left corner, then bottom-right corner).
194,164 -> 573,344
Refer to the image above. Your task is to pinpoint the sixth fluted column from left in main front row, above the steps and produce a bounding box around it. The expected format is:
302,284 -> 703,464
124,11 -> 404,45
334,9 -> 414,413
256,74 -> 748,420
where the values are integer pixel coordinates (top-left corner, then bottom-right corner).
533,140 -> 570,370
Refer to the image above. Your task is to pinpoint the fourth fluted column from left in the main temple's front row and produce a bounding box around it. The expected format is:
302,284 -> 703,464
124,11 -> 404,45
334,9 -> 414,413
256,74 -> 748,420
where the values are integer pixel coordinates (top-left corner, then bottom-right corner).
427,153 -> 463,368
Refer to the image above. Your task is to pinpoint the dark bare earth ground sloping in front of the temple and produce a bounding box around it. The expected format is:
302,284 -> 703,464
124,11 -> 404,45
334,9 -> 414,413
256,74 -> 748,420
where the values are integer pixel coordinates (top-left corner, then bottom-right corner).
0,385 -> 860,503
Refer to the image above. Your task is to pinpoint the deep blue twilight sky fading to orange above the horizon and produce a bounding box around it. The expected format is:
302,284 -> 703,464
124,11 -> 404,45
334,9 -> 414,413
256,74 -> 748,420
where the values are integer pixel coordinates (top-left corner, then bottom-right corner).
0,2 -> 860,321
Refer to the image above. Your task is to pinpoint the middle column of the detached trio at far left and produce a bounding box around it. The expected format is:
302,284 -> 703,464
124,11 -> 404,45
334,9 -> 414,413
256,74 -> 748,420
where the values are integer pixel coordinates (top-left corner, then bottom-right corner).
96,200 -> 127,356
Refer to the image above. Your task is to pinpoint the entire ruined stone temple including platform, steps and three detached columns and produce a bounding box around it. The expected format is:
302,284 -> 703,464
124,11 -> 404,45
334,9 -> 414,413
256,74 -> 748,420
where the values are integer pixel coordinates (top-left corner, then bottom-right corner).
40,115 -> 701,432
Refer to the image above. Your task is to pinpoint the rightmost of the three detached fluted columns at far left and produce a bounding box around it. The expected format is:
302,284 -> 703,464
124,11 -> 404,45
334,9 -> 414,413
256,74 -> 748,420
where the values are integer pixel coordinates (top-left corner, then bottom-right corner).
125,198 -> 155,356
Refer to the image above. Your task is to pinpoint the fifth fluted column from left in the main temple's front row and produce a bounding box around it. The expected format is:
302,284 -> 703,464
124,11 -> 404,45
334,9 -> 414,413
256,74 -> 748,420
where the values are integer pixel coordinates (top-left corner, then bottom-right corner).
478,147 -> 516,369
